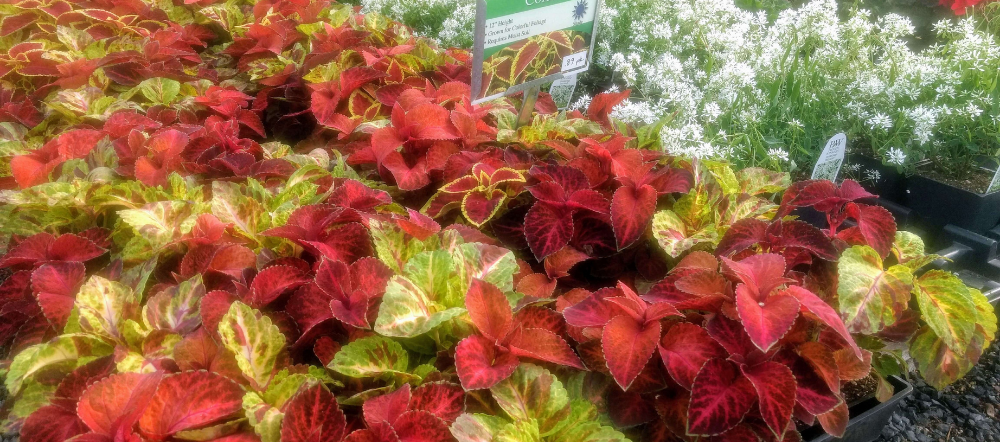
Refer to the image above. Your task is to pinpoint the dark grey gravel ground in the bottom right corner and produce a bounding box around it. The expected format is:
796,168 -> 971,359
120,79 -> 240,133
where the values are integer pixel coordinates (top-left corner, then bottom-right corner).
878,332 -> 1000,442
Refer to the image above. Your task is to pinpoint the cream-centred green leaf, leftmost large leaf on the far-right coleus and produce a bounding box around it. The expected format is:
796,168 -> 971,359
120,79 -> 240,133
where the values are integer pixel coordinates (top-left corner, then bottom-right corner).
837,246 -> 913,334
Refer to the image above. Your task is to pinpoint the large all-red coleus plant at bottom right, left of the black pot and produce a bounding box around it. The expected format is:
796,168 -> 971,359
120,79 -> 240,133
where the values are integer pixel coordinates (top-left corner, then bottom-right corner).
563,252 -> 868,440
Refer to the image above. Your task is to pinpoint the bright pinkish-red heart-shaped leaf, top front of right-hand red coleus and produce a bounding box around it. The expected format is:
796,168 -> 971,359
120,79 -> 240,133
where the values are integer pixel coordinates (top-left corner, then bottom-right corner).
736,285 -> 799,352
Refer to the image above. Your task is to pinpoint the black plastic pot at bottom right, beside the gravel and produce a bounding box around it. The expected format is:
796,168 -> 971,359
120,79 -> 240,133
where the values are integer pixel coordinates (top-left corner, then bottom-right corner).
802,376 -> 913,442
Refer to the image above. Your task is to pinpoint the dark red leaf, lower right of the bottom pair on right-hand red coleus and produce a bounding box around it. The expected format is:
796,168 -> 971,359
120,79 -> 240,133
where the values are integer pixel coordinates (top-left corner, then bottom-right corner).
743,361 -> 796,437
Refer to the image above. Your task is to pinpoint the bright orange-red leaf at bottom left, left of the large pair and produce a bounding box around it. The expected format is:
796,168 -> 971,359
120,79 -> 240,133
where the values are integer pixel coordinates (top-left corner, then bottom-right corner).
77,373 -> 163,437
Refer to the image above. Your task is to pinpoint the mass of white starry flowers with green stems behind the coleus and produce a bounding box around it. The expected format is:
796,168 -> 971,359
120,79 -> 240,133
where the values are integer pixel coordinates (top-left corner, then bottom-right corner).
370,0 -> 1000,181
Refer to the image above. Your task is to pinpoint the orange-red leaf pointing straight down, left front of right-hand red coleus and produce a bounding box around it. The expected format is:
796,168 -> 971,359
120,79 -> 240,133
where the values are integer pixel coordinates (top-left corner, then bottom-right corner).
601,315 -> 661,390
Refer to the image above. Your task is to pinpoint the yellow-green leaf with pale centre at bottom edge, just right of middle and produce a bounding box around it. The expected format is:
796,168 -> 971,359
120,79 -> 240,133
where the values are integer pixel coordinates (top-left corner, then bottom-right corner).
490,363 -> 570,436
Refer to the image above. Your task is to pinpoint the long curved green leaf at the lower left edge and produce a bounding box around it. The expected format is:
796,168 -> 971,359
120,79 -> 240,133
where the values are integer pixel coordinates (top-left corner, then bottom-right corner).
4,334 -> 114,396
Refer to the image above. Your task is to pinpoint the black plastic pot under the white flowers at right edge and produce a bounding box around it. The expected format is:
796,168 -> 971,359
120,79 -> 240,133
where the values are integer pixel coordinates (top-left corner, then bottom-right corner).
907,175 -> 1000,235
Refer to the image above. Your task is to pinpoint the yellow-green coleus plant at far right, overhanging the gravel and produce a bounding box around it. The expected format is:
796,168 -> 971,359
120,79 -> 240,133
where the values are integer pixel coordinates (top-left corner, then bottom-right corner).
837,232 -> 996,390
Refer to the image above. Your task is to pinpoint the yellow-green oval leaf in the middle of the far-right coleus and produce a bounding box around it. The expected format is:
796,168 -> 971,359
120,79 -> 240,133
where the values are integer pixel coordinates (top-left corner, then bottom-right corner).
913,270 -> 978,354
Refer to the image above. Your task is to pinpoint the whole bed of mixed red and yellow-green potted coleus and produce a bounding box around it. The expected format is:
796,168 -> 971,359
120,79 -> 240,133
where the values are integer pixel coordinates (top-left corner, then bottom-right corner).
0,0 -> 996,442
